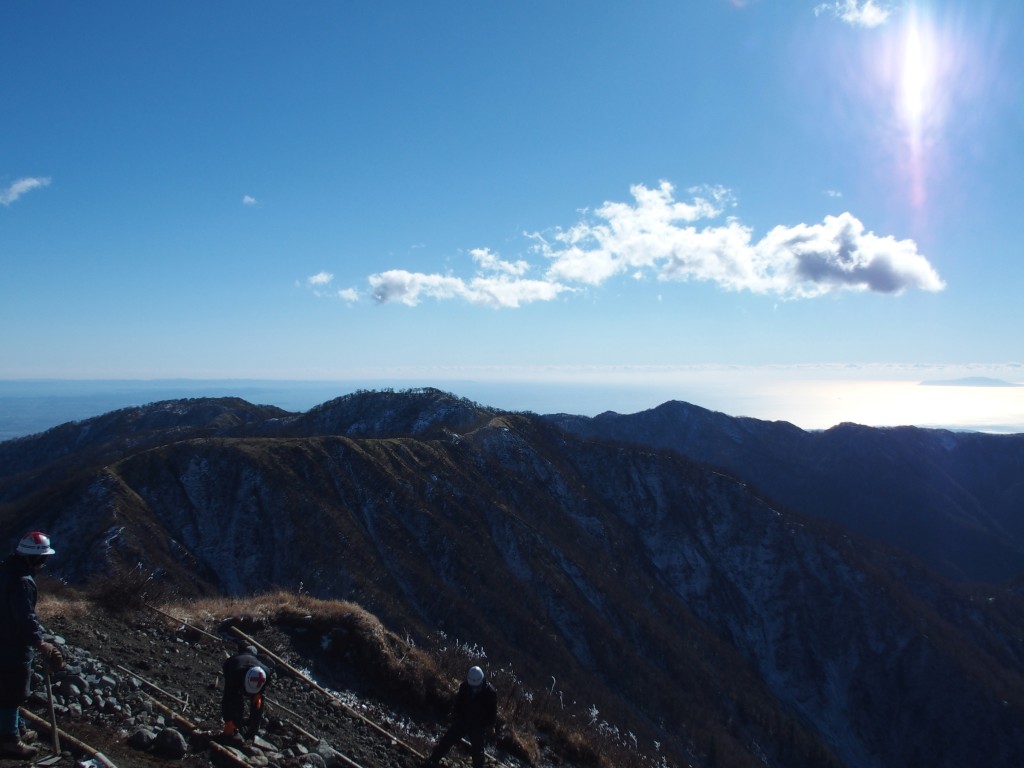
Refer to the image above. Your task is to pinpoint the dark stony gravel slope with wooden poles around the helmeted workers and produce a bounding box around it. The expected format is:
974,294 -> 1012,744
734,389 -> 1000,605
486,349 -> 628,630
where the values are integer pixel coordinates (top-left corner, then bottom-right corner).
9,610 -> 479,768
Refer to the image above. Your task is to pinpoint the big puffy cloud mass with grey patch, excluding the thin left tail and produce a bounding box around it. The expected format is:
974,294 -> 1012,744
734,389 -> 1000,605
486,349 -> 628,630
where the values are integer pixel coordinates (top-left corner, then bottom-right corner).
537,182 -> 944,298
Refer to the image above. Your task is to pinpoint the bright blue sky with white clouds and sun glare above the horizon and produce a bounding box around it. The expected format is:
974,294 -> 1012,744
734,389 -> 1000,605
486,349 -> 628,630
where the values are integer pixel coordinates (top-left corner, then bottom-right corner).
0,0 -> 1024,426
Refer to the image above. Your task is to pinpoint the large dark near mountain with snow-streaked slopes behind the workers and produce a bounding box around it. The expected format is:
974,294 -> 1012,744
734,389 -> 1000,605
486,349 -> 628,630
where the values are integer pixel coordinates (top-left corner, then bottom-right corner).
0,390 -> 1024,768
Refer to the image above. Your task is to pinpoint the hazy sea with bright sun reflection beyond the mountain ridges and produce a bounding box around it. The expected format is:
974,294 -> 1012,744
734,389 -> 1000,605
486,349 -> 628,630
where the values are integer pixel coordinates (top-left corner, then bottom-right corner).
0,368 -> 1024,440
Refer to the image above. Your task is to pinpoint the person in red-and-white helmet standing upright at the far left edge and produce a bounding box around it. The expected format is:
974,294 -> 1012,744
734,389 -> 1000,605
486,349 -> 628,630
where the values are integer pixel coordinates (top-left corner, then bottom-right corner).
0,531 -> 63,760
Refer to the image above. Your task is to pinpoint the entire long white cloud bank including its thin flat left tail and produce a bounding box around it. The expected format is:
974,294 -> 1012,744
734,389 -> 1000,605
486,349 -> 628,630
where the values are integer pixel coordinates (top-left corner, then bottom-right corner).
369,181 -> 945,307
